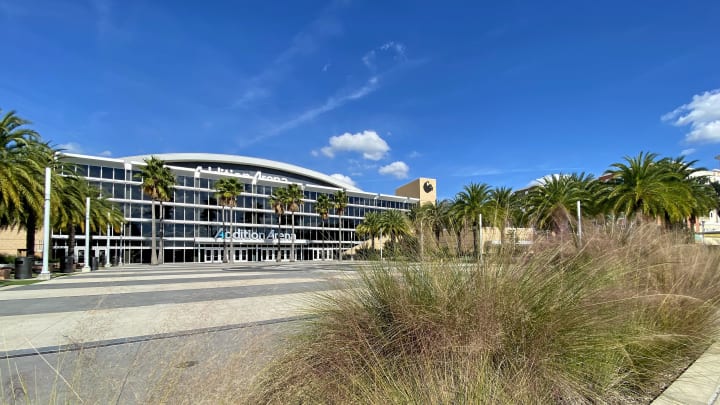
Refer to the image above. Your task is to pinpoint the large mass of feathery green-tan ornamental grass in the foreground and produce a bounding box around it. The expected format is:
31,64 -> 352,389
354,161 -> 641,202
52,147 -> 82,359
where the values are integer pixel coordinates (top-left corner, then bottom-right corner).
250,226 -> 720,404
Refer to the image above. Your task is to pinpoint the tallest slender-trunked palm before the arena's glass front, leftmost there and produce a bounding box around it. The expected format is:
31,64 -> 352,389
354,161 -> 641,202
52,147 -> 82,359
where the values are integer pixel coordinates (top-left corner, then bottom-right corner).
135,156 -> 175,265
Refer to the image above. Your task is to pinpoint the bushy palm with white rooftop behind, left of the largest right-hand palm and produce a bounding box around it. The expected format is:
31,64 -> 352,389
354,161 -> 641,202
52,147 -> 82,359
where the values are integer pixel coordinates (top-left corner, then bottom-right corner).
525,173 -> 595,237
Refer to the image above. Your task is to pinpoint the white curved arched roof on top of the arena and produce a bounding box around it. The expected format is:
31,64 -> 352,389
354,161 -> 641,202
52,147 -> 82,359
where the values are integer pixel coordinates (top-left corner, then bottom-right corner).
118,153 -> 362,191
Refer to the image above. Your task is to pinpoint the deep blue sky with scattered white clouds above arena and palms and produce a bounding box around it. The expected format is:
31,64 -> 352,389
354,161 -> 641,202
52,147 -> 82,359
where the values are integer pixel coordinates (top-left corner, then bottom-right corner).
0,0 -> 720,197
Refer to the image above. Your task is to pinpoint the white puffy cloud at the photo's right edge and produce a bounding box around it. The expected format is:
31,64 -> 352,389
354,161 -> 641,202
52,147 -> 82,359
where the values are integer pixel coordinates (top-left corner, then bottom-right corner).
662,89 -> 720,143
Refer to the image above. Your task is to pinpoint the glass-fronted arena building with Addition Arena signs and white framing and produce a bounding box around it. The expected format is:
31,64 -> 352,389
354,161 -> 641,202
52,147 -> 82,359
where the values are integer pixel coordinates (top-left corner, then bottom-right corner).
47,153 -> 424,263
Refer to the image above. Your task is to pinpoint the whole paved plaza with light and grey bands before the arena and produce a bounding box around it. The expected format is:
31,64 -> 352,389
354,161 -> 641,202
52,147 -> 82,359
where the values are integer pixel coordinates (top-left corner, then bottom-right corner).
0,262 -> 355,403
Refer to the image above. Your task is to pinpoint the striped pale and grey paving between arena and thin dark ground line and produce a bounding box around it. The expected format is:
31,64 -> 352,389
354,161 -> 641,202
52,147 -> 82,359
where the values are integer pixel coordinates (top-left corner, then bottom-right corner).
0,262 -> 349,357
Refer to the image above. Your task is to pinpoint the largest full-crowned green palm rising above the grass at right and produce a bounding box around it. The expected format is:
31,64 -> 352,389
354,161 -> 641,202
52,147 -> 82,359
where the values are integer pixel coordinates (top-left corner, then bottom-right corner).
605,152 -> 692,226
